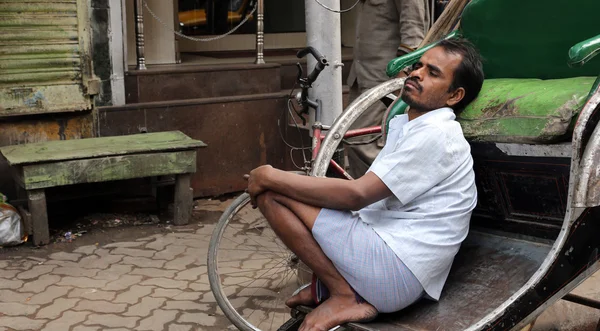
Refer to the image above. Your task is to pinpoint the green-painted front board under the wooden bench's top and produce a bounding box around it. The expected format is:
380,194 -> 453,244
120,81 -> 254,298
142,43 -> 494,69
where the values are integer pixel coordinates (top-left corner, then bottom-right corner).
22,151 -> 196,190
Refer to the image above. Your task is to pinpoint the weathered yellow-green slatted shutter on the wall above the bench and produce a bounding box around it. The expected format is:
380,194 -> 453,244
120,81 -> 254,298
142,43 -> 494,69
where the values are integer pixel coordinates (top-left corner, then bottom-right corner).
0,0 -> 98,117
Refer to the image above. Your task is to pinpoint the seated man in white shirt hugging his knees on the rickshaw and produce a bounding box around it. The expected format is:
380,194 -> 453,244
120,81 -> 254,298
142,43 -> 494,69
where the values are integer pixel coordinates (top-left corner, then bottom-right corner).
245,39 -> 483,331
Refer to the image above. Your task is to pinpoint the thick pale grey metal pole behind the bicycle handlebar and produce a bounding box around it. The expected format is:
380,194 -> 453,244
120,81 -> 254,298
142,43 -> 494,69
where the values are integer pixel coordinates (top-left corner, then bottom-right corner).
304,0 -> 343,125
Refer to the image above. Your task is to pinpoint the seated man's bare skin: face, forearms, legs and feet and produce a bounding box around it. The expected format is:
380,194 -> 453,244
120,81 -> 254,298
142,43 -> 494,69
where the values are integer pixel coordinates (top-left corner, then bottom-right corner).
244,47 -> 465,331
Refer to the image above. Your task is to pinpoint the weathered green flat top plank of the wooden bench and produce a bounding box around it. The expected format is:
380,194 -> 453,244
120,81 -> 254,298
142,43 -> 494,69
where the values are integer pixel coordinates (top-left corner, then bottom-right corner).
0,131 -> 206,165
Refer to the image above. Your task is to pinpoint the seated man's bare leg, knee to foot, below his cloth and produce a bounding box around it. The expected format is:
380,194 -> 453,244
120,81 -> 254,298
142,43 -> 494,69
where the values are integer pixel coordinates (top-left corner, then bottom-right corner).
257,191 -> 377,331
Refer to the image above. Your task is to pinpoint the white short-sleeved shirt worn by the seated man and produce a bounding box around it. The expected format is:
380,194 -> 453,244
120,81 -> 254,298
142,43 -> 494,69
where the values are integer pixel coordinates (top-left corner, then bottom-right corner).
357,108 -> 477,300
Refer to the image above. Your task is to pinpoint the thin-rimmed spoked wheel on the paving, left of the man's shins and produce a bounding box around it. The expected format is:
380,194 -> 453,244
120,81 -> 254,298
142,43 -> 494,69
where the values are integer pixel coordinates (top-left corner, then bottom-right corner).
209,194 -> 310,331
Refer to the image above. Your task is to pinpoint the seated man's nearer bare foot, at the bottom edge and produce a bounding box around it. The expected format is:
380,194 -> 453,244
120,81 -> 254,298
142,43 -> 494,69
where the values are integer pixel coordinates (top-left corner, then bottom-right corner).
298,295 -> 377,331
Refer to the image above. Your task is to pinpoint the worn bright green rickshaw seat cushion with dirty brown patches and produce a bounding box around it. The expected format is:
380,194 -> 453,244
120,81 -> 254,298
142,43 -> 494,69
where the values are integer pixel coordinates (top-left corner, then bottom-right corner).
458,77 -> 595,143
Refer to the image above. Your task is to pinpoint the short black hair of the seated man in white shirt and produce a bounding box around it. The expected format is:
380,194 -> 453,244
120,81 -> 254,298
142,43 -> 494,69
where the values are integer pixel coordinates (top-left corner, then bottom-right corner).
436,38 -> 483,115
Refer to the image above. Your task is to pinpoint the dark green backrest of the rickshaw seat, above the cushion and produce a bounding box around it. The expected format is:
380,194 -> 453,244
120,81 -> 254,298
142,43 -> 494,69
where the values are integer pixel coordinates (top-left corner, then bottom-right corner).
460,0 -> 600,79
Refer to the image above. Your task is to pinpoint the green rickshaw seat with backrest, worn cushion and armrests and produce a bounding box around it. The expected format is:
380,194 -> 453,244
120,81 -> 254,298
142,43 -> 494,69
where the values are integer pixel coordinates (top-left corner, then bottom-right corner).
387,0 -> 600,143
